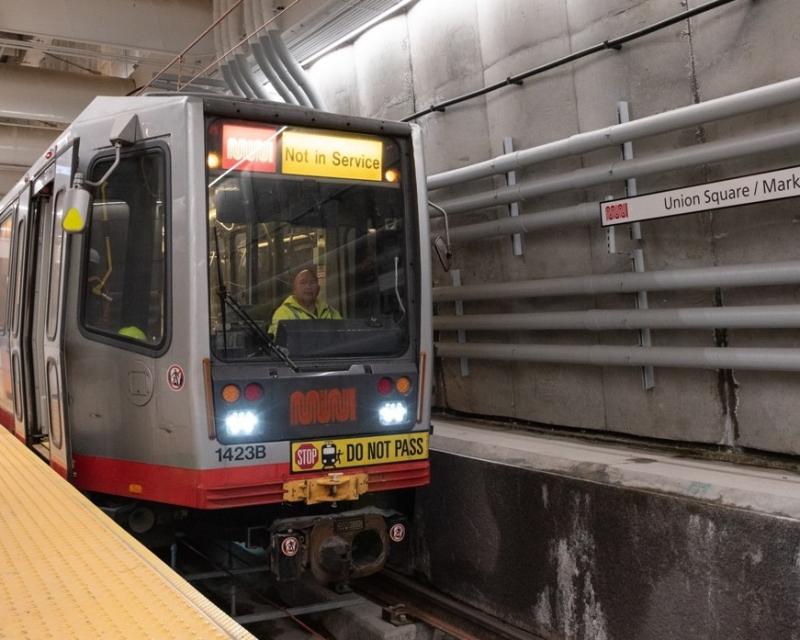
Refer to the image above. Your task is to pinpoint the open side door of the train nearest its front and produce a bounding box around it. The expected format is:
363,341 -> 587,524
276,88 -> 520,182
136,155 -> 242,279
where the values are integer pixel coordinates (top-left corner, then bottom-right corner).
21,147 -> 76,478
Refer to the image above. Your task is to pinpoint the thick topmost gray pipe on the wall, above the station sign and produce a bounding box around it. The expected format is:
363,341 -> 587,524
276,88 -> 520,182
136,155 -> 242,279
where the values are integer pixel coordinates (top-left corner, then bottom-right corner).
438,125 -> 800,216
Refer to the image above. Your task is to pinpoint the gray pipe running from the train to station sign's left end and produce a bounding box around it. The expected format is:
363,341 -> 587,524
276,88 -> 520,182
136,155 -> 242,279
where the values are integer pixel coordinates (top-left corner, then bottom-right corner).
450,202 -> 600,242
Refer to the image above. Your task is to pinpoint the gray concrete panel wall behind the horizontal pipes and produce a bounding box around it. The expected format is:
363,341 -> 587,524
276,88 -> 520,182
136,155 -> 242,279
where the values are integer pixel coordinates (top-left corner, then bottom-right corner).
310,0 -> 800,454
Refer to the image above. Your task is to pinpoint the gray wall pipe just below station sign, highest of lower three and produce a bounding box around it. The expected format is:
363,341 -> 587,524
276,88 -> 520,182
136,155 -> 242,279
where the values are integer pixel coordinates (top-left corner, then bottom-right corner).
433,261 -> 800,302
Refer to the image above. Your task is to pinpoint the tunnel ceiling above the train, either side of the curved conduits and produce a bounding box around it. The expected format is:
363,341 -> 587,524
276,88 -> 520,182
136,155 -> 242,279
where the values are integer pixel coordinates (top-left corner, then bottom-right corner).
0,0 -> 413,196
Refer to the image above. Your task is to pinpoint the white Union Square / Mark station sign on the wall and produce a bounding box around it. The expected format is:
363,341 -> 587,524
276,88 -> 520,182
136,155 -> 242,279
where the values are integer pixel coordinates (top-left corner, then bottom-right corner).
600,167 -> 800,227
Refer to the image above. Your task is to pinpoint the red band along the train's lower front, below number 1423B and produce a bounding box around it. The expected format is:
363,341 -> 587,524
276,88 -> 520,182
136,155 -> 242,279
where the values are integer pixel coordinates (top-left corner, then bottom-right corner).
73,455 -> 430,509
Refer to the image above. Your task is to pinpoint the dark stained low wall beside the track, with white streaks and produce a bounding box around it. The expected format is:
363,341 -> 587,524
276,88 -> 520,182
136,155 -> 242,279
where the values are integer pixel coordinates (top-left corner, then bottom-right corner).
414,444 -> 800,640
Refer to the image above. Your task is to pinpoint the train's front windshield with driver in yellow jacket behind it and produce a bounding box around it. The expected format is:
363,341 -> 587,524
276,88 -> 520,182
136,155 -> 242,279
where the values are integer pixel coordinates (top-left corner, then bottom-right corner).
207,120 -> 409,362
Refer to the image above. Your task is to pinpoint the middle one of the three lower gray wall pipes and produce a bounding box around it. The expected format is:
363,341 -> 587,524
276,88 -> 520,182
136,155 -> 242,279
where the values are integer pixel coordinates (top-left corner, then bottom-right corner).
433,304 -> 800,331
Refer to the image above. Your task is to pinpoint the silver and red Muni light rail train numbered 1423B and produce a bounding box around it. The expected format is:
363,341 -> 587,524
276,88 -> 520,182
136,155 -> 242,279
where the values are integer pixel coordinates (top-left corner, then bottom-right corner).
0,95 -> 432,582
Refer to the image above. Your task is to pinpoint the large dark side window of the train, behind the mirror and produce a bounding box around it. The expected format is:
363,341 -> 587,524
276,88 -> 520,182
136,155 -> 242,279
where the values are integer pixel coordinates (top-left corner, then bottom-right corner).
81,146 -> 168,350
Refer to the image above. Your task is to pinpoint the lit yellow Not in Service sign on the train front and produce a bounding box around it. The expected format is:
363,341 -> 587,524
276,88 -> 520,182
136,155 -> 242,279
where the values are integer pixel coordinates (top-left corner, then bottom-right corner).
282,129 -> 383,182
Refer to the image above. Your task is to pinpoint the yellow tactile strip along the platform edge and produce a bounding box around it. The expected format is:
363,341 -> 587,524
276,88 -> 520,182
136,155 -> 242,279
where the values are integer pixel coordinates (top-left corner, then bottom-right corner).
0,428 -> 253,640
